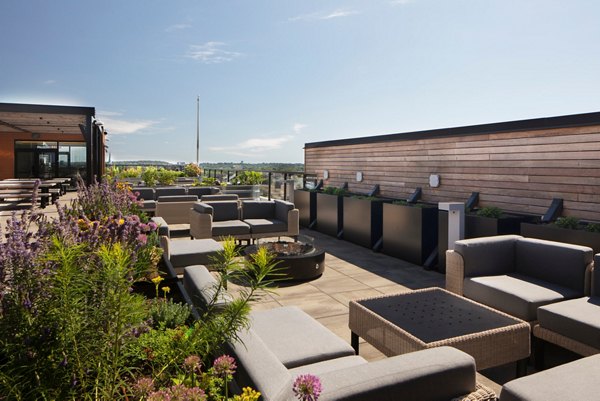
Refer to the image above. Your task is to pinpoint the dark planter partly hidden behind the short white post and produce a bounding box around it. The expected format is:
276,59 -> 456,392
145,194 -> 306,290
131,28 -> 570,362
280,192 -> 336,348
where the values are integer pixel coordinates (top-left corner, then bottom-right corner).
438,210 -> 527,272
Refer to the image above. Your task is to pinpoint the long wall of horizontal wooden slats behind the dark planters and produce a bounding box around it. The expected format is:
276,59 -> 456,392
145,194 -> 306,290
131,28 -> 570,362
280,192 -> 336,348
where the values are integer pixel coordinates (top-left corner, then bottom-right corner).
305,125 -> 600,221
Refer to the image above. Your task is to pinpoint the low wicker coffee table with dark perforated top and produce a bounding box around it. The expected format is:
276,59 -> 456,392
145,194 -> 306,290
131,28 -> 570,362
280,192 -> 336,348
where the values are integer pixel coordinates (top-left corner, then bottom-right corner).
348,288 -> 530,374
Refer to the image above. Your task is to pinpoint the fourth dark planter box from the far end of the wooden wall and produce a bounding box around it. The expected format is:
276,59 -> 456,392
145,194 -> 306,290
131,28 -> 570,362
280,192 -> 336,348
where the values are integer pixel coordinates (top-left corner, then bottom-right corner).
382,203 -> 438,266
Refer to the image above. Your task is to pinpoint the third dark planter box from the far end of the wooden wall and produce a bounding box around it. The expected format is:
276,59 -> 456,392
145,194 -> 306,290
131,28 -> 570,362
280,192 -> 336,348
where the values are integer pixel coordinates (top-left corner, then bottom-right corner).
343,196 -> 384,249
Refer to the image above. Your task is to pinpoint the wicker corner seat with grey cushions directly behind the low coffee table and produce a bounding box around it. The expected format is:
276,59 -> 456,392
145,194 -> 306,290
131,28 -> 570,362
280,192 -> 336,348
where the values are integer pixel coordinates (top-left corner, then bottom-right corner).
446,235 -> 593,322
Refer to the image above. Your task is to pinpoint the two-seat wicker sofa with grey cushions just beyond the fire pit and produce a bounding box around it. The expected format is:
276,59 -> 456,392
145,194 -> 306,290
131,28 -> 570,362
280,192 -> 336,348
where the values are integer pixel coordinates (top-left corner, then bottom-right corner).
189,199 -> 299,240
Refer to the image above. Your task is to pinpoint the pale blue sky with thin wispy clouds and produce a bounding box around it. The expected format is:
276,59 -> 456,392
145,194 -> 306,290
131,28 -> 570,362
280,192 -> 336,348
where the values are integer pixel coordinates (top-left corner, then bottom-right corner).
0,0 -> 600,162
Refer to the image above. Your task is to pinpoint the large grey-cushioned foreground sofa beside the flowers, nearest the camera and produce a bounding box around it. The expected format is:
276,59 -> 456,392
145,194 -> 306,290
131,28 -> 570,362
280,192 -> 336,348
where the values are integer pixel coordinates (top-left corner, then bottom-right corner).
228,306 -> 495,401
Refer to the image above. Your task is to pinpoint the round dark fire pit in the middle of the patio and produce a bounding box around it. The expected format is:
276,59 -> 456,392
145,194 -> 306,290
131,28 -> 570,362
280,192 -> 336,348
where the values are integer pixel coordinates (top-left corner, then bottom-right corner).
244,241 -> 325,280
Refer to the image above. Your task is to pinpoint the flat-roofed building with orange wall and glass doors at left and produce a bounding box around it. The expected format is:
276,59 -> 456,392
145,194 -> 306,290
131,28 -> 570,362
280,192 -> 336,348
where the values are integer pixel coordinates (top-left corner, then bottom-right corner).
0,103 -> 106,182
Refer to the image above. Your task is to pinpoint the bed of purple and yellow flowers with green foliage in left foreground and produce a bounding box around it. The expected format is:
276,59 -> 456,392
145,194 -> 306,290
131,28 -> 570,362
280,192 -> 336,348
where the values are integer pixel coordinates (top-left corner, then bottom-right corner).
0,182 -> 314,401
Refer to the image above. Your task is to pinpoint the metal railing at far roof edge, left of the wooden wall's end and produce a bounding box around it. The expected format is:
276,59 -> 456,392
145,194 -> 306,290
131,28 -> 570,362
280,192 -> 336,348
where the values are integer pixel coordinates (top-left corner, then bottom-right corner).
203,169 -> 317,200
